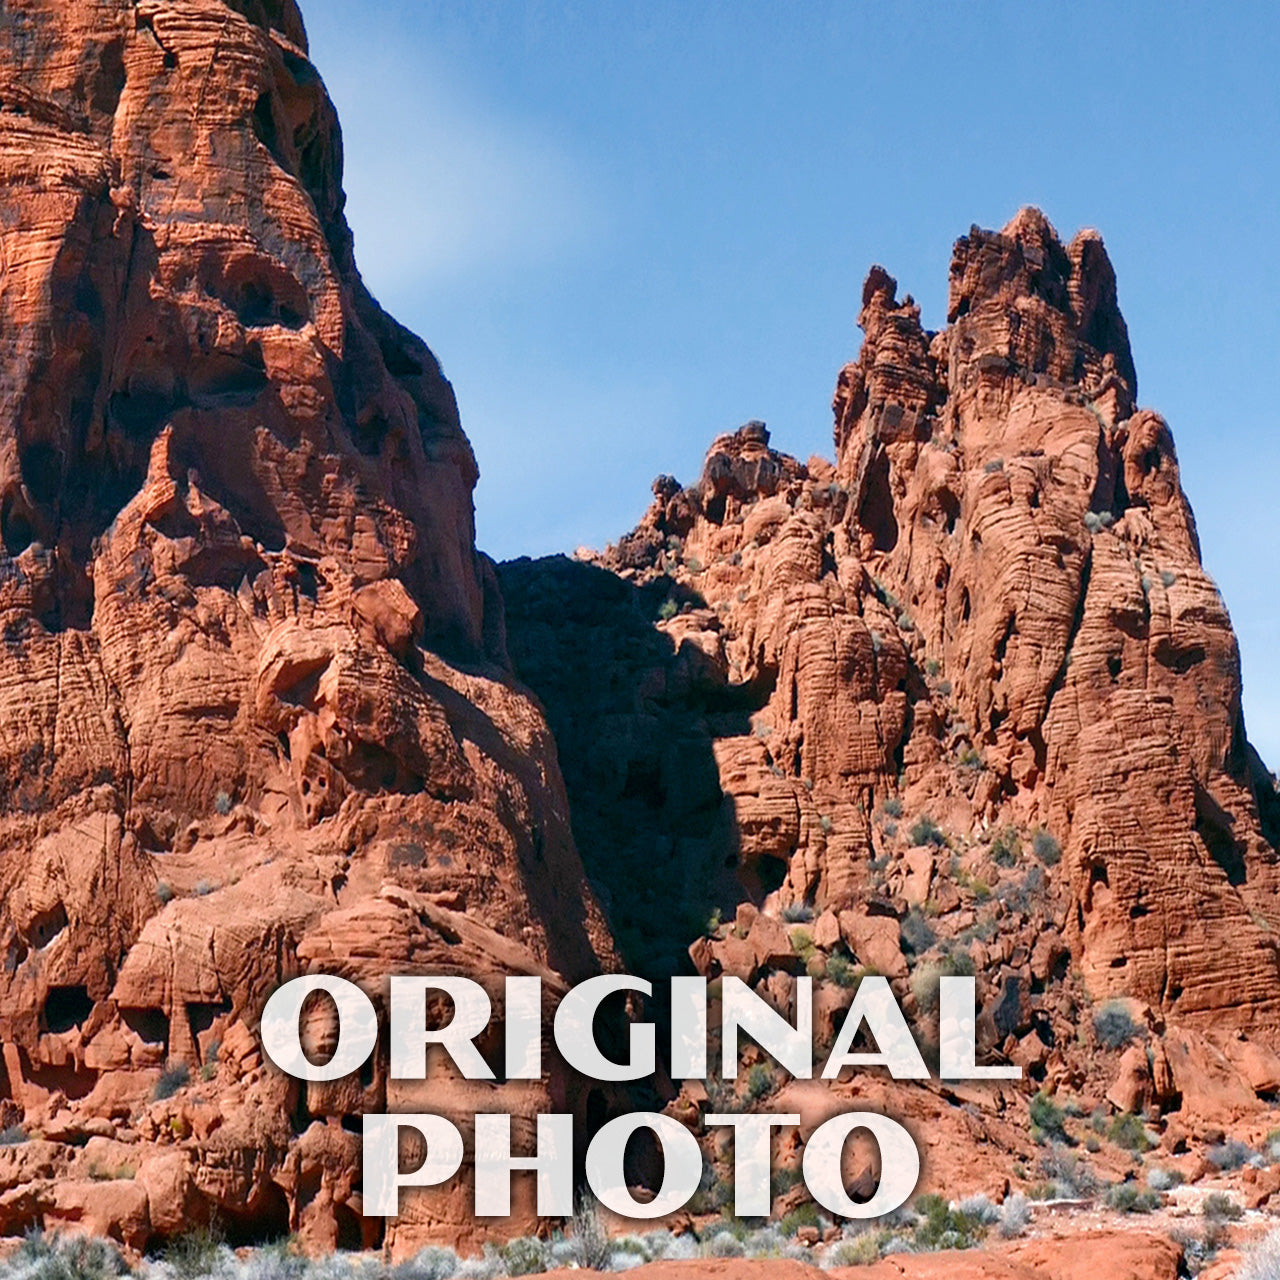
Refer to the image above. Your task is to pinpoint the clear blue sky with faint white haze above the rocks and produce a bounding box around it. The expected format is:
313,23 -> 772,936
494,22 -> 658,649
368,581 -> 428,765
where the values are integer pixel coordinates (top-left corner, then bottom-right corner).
302,0 -> 1280,765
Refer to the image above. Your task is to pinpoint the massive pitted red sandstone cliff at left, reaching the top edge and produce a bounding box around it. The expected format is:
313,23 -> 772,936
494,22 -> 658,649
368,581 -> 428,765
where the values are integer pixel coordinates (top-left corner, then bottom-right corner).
0,0 -> 609,1248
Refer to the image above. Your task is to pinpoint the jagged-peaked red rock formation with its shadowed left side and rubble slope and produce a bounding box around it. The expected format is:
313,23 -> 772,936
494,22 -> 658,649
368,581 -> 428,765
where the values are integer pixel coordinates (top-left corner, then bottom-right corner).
499,210 -> 1280,1228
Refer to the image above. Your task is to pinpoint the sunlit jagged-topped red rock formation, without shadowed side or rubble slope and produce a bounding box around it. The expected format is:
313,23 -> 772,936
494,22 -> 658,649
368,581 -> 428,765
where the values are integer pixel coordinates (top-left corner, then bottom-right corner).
573,210 -> 1280,1027
